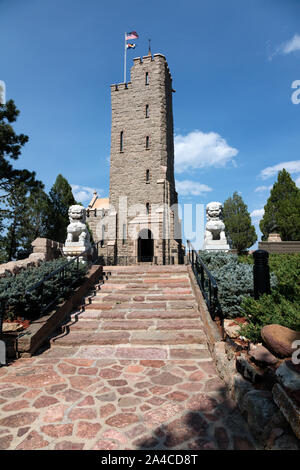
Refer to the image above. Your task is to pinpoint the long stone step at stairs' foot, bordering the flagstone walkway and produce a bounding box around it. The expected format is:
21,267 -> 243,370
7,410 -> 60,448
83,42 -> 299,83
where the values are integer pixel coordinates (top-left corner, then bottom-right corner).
50,330 -> 206,347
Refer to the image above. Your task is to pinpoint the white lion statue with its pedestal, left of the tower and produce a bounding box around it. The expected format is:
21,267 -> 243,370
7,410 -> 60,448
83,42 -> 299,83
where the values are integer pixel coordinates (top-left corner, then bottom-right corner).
63,205 -> 91,262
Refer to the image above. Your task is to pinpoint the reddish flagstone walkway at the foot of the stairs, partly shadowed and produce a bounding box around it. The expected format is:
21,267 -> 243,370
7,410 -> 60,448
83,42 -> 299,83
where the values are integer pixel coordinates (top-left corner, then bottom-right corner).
0,266 -> 255,450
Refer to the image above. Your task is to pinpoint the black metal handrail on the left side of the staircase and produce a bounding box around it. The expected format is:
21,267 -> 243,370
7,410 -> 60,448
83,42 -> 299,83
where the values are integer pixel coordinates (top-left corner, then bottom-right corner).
0,242 -> 100,335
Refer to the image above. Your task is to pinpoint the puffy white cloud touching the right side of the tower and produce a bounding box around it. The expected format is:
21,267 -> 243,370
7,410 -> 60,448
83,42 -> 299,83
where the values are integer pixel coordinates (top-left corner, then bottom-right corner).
174,130 -> 238,173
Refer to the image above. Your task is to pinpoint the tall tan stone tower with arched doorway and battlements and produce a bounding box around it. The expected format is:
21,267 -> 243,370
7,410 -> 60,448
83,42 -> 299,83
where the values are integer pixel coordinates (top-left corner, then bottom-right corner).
88,54 -> 182,264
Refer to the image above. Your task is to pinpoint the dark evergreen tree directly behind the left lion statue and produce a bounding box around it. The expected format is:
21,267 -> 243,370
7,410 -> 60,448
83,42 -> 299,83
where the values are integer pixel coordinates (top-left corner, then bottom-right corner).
49,175 -> 76,243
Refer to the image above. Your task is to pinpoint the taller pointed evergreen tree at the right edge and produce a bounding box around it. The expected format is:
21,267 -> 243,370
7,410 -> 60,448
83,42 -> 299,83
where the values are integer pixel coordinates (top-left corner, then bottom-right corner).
259,169 -> 300,241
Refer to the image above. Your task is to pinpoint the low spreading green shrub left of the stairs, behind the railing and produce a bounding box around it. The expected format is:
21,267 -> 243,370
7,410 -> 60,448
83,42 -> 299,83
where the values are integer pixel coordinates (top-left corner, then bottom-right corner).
0,258 -> 87,320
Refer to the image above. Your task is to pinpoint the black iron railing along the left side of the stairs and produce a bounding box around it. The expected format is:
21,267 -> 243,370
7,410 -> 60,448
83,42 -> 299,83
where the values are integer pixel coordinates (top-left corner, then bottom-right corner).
0,242 -> 101,335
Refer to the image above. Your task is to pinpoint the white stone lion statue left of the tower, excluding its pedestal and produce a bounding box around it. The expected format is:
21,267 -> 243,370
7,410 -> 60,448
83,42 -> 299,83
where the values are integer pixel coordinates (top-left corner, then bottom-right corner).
66,205 -> 90,246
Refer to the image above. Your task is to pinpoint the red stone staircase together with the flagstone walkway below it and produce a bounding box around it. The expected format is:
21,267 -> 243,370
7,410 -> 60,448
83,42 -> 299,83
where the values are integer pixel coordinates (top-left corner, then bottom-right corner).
0,266 -> 255,450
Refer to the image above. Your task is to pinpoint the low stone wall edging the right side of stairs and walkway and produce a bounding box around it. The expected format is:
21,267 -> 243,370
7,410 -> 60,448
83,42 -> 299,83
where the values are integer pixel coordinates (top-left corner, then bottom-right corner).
188,267 -> 300,450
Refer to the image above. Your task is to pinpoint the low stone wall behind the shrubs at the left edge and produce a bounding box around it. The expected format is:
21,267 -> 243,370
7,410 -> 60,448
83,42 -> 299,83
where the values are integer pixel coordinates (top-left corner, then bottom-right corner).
0,238 -> 63,277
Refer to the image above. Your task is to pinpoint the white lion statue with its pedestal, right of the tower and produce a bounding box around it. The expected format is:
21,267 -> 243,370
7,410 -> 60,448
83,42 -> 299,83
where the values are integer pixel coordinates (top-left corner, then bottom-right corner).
202,202 -> 230,251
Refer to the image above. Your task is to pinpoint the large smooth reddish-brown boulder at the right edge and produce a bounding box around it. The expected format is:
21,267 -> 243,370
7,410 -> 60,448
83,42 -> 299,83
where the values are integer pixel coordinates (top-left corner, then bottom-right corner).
261,324 -> 300,357
